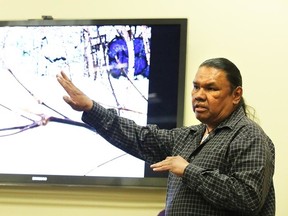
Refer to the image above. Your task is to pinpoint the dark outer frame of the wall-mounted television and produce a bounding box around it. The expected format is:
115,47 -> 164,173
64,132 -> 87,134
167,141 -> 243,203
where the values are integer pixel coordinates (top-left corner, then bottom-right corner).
0,18 -> 188,187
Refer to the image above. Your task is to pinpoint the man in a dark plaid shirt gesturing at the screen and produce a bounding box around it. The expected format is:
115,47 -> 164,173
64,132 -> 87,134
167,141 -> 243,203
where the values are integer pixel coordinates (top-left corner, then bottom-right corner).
57,58 -> 275,216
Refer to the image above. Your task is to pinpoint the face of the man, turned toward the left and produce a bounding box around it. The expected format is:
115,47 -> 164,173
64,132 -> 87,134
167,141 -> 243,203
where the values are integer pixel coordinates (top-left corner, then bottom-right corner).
192,67 -> 242,128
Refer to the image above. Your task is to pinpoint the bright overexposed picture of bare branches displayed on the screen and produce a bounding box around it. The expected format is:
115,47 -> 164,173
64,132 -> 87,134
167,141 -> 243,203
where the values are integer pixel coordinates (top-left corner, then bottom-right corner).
0,25 -> 151,177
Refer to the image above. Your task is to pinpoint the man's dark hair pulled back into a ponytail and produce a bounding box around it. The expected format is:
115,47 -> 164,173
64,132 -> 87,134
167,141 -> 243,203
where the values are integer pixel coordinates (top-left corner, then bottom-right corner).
199,58 -> 255,118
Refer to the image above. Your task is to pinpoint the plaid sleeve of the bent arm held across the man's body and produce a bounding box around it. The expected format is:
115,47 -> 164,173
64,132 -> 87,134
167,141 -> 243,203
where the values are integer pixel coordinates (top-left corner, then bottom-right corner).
182,127 -> 274,215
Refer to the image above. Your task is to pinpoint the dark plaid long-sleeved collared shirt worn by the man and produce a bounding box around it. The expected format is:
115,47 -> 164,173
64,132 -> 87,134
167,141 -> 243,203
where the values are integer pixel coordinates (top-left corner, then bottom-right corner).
82,102 -> 275,216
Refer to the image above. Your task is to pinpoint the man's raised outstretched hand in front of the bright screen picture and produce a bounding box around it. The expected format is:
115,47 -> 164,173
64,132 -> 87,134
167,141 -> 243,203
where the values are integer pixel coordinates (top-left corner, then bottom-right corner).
56,71 -> 93,111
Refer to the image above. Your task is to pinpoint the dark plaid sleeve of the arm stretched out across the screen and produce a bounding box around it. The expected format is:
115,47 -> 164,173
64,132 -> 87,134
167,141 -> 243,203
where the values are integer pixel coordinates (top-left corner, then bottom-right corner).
82,102 -> 173,163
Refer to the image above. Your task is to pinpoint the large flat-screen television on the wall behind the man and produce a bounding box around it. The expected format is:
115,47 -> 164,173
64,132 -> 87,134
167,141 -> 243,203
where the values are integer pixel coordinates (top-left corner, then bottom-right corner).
0,18 -> 187,187
